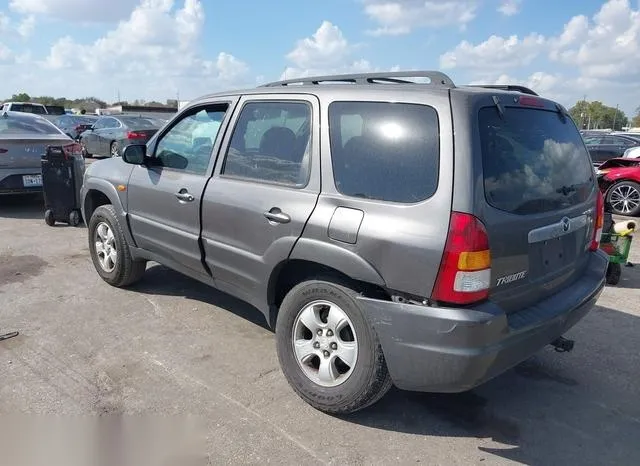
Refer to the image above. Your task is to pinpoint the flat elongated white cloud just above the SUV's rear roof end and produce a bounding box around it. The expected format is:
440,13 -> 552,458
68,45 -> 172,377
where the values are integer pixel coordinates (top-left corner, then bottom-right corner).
440,34 -> 546,71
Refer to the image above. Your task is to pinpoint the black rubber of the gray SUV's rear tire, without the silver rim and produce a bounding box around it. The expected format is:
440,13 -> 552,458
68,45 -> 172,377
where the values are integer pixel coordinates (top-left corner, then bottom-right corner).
276,280 -> 393,414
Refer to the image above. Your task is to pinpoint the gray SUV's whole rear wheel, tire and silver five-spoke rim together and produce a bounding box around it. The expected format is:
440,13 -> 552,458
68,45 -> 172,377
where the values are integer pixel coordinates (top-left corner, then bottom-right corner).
276,280 -> 392,414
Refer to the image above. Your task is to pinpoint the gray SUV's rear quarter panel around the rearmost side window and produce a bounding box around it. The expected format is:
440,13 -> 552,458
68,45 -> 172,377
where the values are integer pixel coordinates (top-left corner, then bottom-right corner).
292,85 -> 454,297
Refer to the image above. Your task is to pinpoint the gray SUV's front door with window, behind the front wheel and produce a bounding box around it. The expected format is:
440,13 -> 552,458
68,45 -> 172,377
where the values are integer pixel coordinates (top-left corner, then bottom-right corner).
128,101 -> 232,274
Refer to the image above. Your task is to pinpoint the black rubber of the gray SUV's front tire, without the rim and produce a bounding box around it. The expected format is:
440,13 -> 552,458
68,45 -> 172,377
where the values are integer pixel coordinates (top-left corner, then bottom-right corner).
88,205 -> 147,288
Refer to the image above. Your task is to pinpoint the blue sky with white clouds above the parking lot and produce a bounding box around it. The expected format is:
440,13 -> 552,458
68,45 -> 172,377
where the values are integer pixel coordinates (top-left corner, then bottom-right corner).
0,0 -> 640,116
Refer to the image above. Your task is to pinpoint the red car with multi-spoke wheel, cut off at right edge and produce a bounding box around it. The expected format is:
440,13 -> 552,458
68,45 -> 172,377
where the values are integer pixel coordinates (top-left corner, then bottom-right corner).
596,158 -> 640,217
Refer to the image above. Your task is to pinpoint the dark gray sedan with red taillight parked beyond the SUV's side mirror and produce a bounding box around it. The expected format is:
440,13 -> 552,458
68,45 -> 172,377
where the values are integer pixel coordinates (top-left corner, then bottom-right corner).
80,115 -> 164,157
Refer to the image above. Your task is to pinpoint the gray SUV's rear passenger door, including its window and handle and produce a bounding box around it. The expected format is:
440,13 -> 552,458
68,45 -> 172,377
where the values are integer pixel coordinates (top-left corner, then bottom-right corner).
202,95 -> 320,301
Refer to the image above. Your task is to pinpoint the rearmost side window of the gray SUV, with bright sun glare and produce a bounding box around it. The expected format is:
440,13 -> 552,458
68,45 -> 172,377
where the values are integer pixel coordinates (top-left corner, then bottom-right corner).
329,102 -> 440,203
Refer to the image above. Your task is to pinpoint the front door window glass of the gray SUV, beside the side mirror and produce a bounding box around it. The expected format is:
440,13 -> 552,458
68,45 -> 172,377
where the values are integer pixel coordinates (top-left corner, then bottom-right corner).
155,104 -> 227,175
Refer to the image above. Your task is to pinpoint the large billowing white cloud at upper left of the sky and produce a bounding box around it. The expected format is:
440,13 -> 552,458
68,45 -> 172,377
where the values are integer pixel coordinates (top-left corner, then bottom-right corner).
3,0 -> 251,101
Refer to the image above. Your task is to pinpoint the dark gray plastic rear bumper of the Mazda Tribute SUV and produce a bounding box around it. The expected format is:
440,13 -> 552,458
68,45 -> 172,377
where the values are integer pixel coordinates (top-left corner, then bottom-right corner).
359,251 -> 608,392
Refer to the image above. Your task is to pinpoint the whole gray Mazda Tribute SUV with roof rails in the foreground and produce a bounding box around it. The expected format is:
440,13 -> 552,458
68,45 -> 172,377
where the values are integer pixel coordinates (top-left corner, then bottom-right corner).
82,71 -> 607,413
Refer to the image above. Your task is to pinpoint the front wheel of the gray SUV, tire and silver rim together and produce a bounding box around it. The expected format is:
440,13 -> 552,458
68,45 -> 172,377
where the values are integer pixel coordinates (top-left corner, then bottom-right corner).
88,205 -> 147,288
